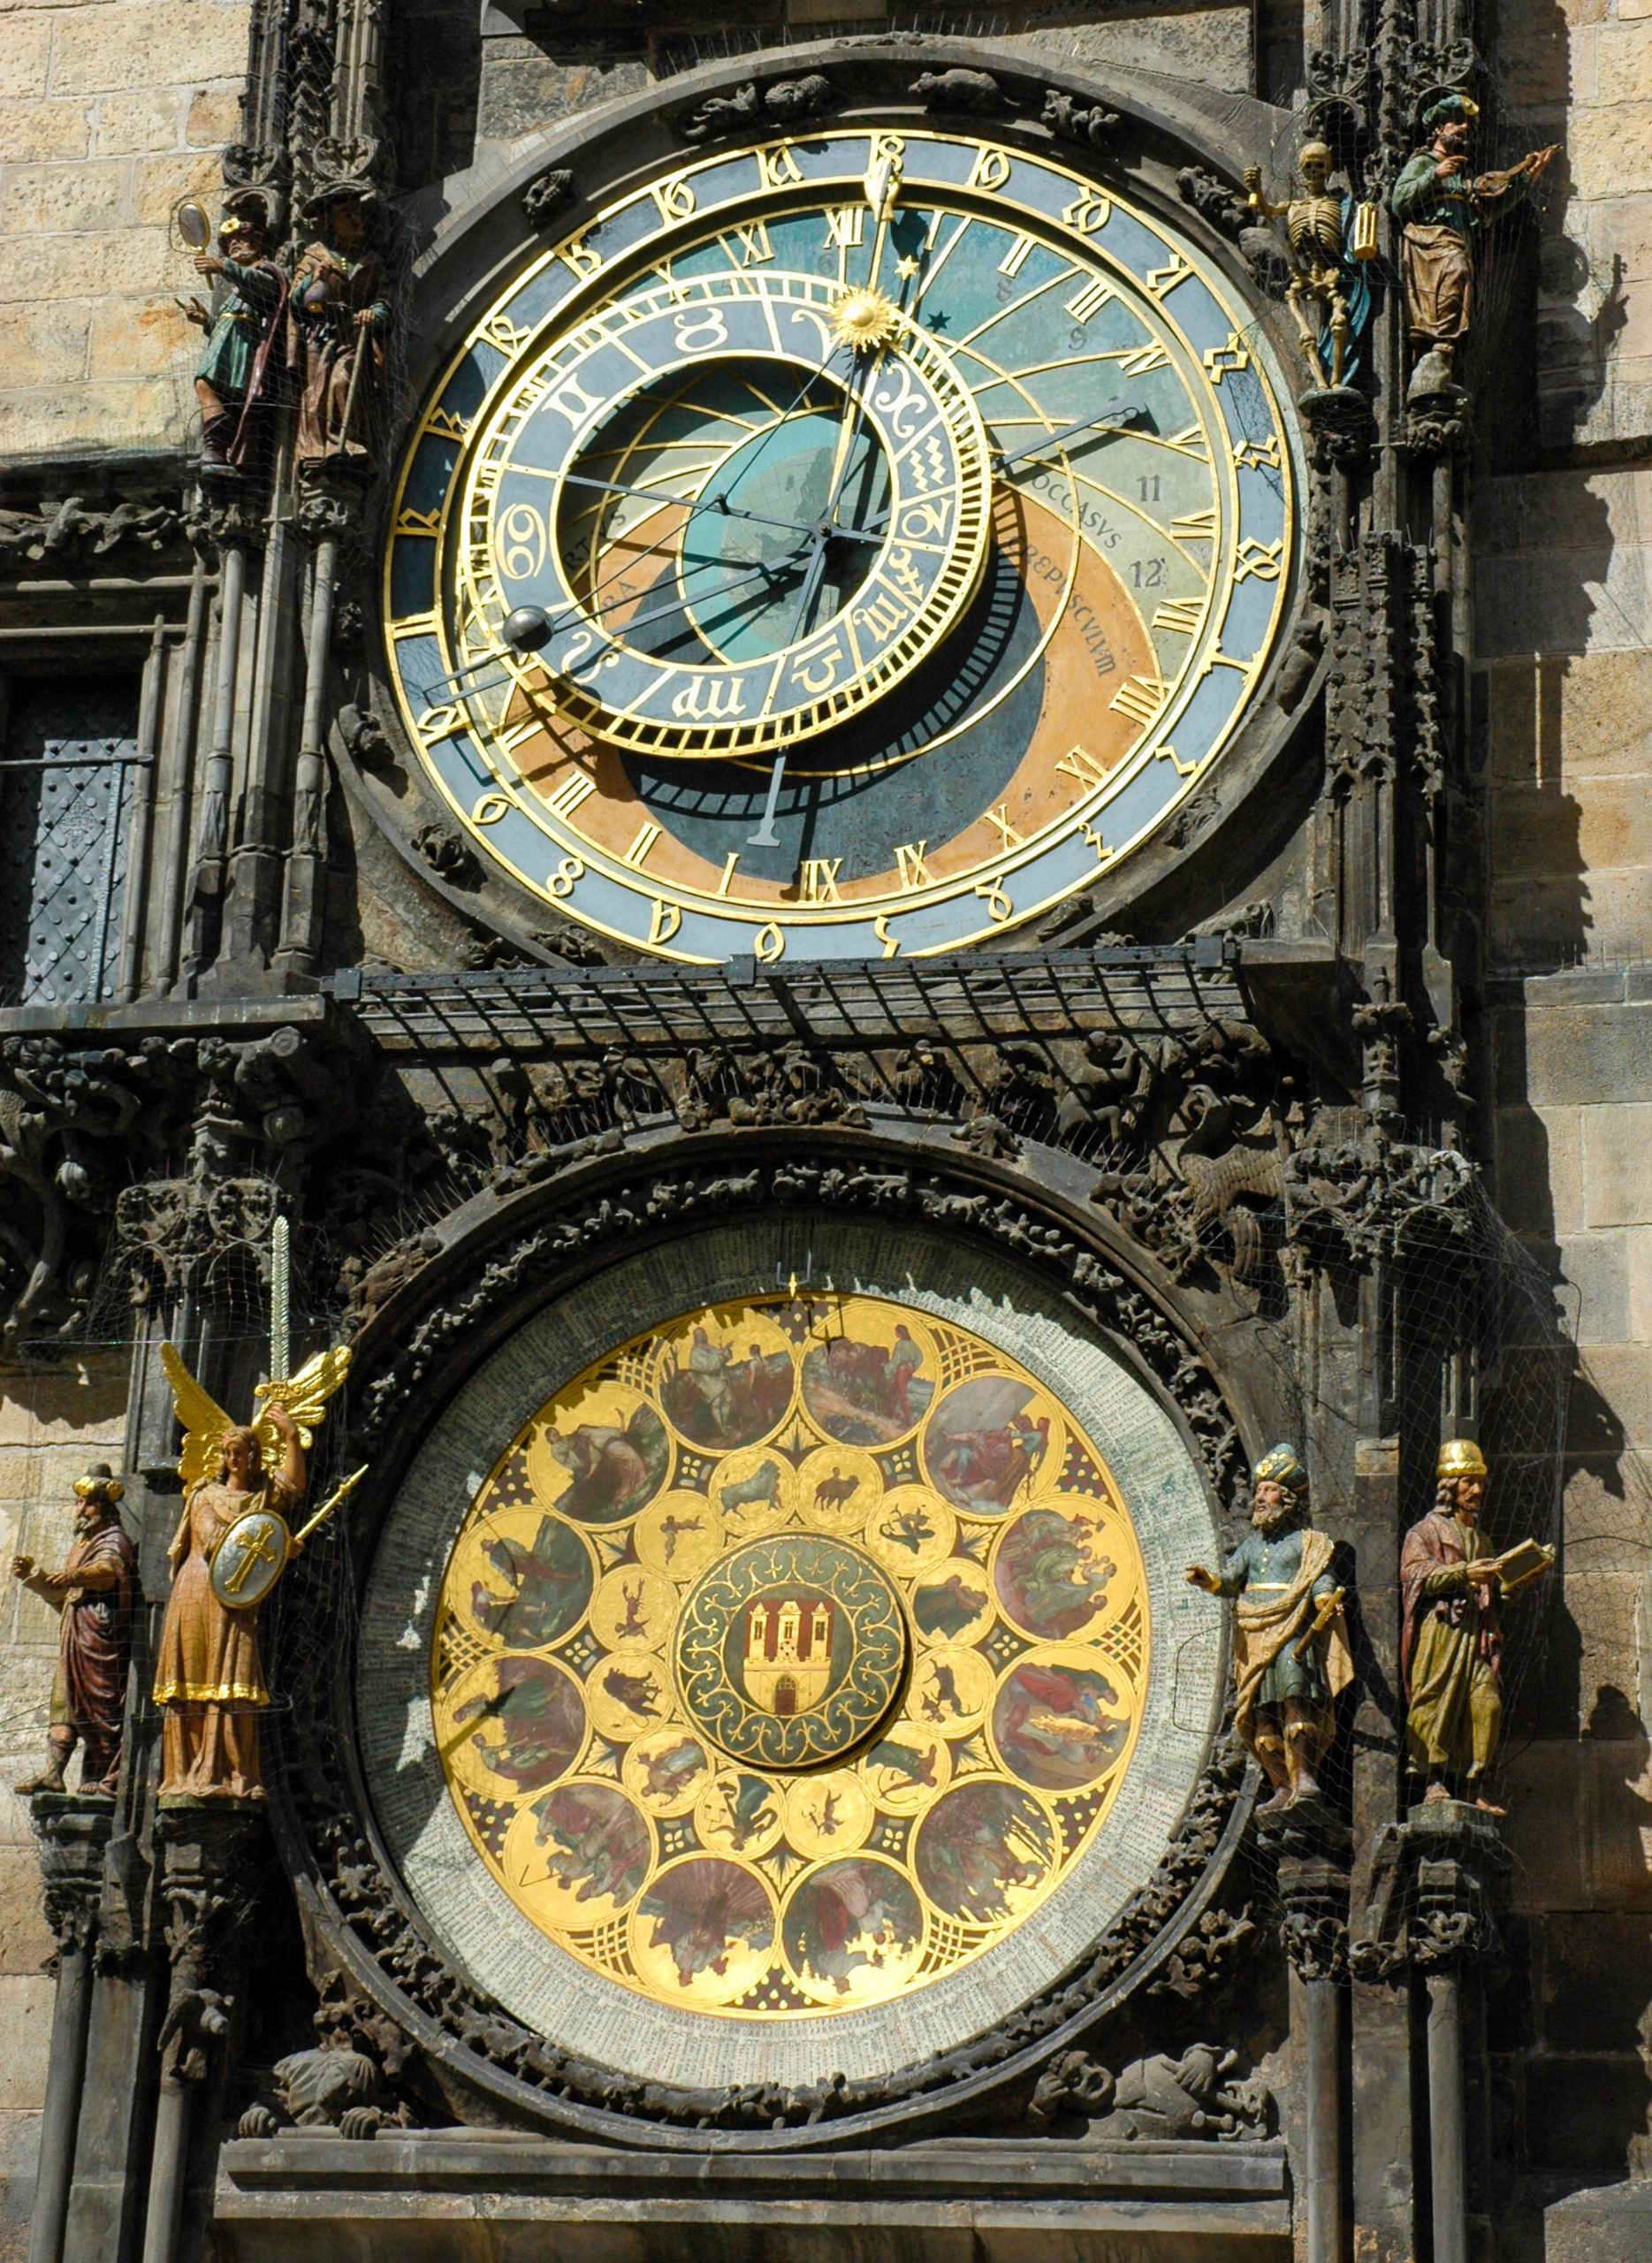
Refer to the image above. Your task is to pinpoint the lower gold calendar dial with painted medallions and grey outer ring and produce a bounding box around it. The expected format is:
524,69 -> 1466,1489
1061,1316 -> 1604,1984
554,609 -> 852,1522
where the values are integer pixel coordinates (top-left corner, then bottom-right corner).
358,1229 -> 1217,2084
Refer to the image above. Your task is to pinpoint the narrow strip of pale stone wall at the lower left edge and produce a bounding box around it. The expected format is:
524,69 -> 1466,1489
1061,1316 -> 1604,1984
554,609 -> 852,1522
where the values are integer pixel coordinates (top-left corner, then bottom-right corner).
0,1355 -> 126,2263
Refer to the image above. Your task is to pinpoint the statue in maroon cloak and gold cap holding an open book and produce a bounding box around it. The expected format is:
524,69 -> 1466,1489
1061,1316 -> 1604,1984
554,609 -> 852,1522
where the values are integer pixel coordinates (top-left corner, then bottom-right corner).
1398,1437 -> 1555,1815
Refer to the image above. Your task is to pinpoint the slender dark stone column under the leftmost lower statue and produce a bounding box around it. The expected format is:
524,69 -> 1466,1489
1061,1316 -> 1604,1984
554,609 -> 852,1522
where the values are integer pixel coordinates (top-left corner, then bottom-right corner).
29,1793 -> 116,2263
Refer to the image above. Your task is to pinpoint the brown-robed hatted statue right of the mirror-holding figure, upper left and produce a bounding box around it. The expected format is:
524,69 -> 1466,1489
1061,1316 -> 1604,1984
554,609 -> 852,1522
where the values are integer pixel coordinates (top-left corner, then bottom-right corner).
287,190 -> 389,470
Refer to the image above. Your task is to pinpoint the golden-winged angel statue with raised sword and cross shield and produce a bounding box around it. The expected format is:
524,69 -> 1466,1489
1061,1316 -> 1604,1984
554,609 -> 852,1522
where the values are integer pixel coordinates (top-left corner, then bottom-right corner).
154,1345 -> 351,1802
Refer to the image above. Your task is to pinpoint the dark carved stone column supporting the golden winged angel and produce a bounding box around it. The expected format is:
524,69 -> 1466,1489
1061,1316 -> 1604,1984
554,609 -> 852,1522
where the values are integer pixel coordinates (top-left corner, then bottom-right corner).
142,1802 -> 265,2263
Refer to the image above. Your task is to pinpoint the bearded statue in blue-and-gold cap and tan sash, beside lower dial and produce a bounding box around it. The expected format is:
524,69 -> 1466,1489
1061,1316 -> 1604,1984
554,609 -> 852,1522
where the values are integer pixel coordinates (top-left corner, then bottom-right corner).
1188,1446 -> 1353,1813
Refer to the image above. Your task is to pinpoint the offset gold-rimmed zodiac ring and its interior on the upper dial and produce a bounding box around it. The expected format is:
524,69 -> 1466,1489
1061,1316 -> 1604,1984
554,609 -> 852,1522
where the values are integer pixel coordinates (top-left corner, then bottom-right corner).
460,270 -> 991,758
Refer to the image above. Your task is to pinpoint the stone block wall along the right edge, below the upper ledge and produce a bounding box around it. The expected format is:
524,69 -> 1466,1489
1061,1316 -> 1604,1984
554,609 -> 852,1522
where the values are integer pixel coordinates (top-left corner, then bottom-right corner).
1475,469 -> 1652,2198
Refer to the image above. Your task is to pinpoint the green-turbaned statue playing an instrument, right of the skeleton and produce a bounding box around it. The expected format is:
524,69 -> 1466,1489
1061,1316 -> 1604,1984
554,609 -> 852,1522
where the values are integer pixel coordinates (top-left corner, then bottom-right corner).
1389,95 -> 1555,380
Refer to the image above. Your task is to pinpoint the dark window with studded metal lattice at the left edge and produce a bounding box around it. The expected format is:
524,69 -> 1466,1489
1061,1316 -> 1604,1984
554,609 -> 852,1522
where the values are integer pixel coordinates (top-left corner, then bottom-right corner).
0,676 -> 138,1005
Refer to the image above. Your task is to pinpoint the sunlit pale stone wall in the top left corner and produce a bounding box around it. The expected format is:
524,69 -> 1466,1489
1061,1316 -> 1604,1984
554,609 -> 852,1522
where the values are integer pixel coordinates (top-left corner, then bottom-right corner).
0,0 -> 249,476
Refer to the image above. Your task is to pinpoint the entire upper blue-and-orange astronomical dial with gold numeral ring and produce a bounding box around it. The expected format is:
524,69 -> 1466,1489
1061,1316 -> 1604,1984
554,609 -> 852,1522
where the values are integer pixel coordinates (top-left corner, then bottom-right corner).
384,129 -> 1299,964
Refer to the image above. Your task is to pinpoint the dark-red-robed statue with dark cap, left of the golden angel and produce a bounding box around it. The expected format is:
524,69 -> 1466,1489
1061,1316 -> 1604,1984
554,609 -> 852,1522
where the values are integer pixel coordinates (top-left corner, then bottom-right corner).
11,1462 -> 138,1797
